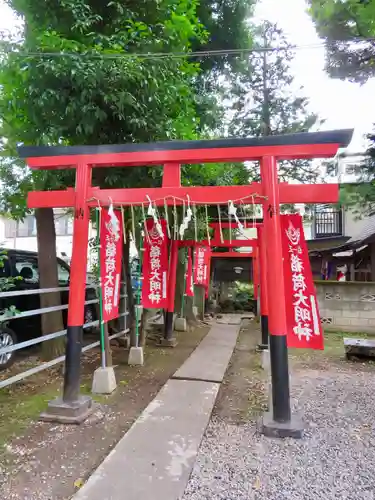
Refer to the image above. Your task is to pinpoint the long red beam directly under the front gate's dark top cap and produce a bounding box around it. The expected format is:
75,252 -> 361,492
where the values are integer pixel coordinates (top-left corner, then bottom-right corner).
26,143 -> 341,169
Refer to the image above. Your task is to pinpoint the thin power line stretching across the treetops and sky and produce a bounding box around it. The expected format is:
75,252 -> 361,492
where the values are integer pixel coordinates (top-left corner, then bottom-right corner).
0,38 -> 375,60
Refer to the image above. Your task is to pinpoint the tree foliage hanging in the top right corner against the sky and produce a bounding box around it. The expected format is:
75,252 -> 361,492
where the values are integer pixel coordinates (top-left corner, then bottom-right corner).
309,0 -> 375,83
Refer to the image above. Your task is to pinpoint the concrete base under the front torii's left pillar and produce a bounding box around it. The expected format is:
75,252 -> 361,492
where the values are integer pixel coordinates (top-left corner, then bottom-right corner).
39,396 -> 94,424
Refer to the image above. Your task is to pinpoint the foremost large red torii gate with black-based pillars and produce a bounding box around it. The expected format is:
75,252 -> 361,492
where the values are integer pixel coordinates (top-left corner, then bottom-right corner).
18,130 -> 353,435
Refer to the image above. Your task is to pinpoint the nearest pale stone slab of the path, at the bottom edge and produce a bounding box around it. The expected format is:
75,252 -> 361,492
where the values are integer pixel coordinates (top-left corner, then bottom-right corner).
73,380 -> 219,500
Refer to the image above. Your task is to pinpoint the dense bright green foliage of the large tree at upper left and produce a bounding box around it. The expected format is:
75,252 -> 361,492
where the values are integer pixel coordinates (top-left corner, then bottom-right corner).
0,0 -> 206,203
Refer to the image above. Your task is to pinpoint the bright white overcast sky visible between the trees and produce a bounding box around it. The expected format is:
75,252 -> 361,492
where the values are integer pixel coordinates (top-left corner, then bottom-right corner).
0,0 -> 375,152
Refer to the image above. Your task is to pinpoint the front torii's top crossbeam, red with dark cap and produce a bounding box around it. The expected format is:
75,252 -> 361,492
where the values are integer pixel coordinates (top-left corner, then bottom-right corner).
19,130 -> 353,169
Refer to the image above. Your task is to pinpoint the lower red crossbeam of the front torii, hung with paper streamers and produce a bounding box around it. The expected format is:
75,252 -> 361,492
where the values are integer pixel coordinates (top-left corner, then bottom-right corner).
27,183 -> 339,208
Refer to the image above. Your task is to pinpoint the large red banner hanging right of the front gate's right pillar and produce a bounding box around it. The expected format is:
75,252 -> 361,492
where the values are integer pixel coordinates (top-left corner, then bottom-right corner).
280,215 -> 324,349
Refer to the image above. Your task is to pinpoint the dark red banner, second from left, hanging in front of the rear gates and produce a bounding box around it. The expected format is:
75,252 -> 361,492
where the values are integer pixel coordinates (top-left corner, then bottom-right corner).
142,219 -> 168,309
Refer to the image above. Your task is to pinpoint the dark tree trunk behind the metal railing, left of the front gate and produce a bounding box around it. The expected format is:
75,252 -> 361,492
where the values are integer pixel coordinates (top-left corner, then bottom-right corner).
35,208 -> 65,360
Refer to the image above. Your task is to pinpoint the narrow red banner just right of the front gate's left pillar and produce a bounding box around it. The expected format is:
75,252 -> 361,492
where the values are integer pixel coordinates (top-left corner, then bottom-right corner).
100,208 -> 122,323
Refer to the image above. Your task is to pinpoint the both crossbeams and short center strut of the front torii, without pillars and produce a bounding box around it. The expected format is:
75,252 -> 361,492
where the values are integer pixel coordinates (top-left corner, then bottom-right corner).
18,130 -> 352,208
